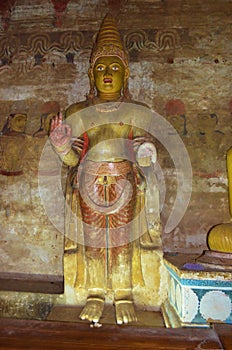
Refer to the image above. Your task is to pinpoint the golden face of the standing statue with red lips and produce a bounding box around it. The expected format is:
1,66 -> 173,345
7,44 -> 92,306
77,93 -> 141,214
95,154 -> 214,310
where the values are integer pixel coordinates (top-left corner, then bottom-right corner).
93,56 -> 125,93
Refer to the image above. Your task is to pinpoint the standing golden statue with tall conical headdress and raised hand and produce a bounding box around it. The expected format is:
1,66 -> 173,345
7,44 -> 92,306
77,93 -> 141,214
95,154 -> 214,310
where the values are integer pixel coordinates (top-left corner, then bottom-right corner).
50,15 -> 160,324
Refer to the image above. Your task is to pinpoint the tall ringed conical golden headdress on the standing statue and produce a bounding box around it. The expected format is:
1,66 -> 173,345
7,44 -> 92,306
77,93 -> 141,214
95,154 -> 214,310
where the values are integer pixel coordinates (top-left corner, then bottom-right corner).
90,14 -> 128,68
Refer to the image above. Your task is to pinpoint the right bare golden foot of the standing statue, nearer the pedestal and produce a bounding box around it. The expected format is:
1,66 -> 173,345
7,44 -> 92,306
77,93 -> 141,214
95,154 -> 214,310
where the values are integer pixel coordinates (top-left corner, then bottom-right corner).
115,300 -> 137,324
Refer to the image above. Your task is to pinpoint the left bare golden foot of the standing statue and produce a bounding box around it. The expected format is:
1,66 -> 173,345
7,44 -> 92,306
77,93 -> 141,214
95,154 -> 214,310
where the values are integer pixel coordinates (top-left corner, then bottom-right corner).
80,297 -> 104,323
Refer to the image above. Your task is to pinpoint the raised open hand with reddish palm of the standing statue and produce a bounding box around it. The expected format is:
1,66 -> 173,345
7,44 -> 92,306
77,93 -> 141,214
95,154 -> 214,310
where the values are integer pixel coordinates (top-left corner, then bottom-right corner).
50,113 -> 72,147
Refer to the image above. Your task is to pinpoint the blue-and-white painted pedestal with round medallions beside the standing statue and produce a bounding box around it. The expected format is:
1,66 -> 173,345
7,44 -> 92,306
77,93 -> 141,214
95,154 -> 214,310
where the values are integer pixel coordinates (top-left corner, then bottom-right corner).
163,254 -> 232,327
